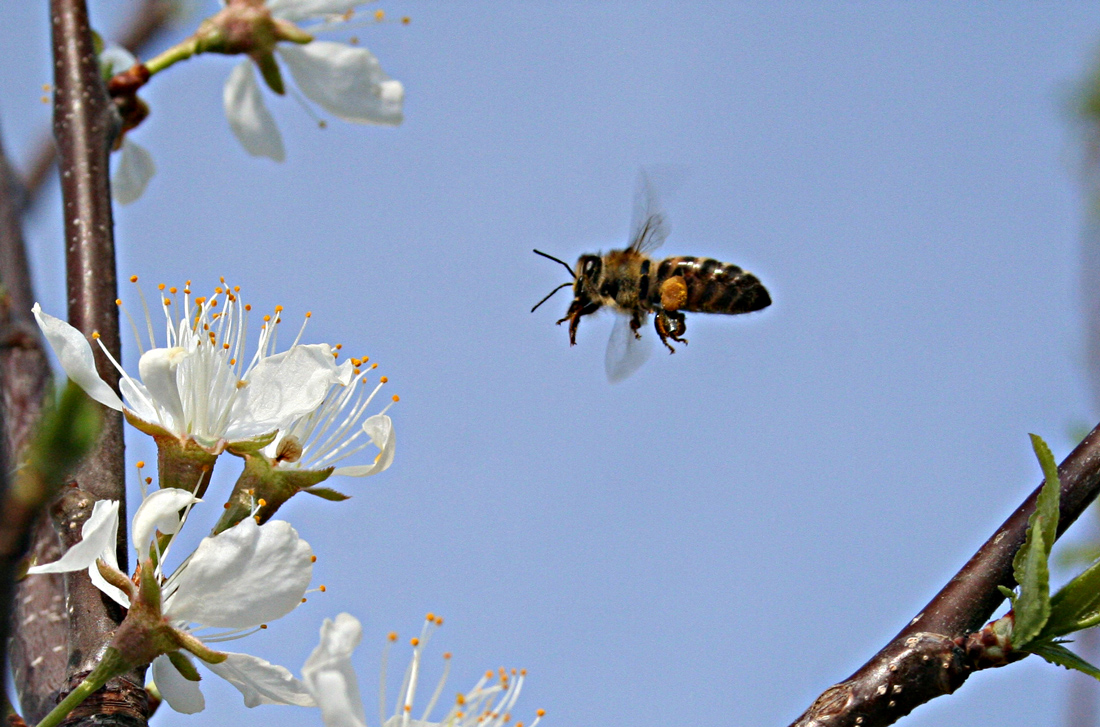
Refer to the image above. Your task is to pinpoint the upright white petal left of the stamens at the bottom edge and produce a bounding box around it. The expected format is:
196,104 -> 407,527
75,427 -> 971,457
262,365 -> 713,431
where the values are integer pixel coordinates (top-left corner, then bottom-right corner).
301,614 -> 366,727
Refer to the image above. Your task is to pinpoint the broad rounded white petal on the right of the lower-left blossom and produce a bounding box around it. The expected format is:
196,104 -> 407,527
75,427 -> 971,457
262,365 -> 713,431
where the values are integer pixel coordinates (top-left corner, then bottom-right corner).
165,518 -> 314,628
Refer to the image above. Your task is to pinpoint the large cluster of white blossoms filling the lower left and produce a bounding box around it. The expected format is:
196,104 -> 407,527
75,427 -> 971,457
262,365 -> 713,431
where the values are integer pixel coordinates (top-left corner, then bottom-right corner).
29,277 -> 542,727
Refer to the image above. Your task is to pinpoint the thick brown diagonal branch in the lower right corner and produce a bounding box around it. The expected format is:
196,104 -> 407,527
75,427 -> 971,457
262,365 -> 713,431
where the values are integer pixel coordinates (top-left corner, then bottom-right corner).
792,426 -> 1100,727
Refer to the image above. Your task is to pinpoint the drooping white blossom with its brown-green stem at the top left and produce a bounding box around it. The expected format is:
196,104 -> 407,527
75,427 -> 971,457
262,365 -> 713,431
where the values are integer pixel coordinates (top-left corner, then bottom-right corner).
107,0 -> 405,205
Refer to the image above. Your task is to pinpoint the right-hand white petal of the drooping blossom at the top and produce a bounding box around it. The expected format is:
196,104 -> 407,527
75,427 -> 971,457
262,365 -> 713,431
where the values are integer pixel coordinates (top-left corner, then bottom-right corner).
276,41 -> 405,125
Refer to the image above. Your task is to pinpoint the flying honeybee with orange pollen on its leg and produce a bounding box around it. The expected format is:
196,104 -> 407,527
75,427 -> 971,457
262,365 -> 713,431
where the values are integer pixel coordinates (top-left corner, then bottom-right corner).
531,172 -> 771,382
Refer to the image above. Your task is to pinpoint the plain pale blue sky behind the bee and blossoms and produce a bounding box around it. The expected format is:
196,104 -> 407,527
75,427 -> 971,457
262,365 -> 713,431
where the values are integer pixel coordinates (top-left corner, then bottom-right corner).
0,0 -> 1100,727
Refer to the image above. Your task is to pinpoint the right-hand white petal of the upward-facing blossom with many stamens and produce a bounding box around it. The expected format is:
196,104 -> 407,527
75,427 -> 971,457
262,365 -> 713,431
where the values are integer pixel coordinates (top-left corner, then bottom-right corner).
233,343 -> 341,441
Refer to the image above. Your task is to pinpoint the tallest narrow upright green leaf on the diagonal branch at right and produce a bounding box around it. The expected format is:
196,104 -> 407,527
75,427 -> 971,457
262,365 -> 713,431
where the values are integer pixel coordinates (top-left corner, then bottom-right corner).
1012,434 -> 1062,649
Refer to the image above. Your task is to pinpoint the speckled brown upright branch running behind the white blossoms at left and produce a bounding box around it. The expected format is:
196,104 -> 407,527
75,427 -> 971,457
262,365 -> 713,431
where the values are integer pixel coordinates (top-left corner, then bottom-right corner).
50,0 -> 146,725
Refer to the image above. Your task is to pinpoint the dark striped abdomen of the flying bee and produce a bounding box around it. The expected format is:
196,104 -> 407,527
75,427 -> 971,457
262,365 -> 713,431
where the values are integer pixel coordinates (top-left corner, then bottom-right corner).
642,256 -> 771,313
